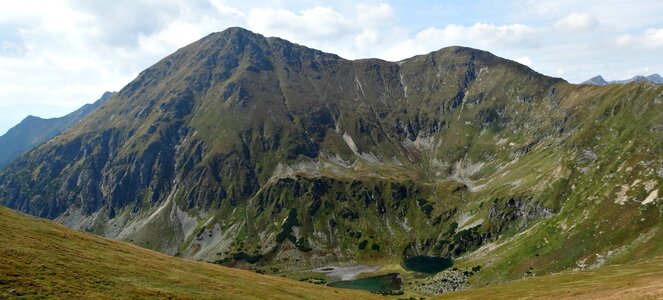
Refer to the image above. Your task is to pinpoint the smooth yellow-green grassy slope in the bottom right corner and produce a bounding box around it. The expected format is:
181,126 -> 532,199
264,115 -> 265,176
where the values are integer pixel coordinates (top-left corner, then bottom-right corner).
440,257 -> 663,299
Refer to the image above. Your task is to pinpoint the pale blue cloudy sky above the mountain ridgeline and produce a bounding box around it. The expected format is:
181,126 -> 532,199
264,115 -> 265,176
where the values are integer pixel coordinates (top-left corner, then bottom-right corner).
0,0 -> 663,134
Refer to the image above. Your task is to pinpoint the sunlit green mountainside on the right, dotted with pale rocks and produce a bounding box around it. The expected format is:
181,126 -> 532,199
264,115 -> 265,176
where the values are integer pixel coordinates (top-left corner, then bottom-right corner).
448,85 -> 663,286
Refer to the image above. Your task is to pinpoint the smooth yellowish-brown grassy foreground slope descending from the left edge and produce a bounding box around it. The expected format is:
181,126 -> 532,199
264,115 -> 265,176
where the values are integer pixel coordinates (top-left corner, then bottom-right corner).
0,206 -> 375,299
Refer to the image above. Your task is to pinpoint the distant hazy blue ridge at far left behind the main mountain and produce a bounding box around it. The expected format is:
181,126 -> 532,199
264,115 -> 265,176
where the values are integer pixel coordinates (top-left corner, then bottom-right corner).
0,92 -> 113,169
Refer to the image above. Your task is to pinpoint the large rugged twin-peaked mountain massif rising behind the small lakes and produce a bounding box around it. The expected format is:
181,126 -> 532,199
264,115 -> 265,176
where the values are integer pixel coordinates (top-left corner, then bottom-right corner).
0,28 -> 663,282
